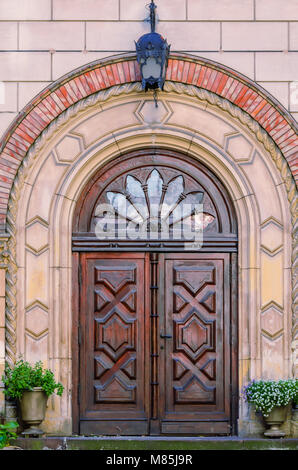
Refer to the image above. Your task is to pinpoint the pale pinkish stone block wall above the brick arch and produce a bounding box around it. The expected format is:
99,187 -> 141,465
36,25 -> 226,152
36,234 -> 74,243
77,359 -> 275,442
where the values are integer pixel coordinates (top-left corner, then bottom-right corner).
0,0 -> 298,140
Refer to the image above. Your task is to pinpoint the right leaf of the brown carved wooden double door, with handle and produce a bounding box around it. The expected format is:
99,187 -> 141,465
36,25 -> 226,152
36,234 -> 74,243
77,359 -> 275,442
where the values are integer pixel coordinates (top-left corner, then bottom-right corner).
161,254 -> 231,433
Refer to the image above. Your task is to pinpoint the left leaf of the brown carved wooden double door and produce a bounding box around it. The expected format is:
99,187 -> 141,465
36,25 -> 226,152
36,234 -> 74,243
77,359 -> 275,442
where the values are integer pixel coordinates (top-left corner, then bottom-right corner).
80,254 -> 147,434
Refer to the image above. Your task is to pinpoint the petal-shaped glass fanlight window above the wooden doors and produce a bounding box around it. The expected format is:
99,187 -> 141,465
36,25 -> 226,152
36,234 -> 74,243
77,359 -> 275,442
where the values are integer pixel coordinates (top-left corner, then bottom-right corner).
94,169 -> 214,239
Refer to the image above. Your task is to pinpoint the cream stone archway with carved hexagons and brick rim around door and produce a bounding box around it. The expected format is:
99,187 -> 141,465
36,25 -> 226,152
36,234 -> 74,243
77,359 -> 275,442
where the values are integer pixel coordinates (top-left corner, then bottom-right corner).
2,53 -> 296,434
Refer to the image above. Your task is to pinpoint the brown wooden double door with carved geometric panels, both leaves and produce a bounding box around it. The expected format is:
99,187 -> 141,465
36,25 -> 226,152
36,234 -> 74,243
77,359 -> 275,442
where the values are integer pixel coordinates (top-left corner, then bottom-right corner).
77,252 -> 237,435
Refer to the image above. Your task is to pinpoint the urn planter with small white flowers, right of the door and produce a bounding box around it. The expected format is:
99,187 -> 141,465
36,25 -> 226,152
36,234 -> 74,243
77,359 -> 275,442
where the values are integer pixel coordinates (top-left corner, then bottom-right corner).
244,379 -> 298,437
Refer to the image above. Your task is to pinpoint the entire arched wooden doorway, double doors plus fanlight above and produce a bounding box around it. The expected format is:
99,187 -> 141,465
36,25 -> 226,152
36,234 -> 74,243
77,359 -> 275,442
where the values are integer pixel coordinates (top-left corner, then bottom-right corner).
73,148 -> 238,435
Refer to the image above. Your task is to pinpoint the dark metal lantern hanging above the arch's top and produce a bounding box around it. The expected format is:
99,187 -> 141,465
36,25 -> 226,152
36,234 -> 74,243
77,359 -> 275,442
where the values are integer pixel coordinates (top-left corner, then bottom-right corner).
136,0 -> 170,91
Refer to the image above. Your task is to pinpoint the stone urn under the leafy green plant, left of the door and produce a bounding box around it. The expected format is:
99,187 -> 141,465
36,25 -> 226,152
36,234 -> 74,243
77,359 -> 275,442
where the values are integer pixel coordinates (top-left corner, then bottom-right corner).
20,387 -> 48,435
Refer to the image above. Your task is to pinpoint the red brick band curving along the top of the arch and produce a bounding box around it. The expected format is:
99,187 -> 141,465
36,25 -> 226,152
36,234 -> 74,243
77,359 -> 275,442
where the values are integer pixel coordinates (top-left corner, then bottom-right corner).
0,54 -> 298,228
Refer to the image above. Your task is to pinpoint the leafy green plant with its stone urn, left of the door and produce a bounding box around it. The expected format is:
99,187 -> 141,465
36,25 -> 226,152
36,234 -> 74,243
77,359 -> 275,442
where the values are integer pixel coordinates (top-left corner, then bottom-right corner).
2,359 -> 64,435
